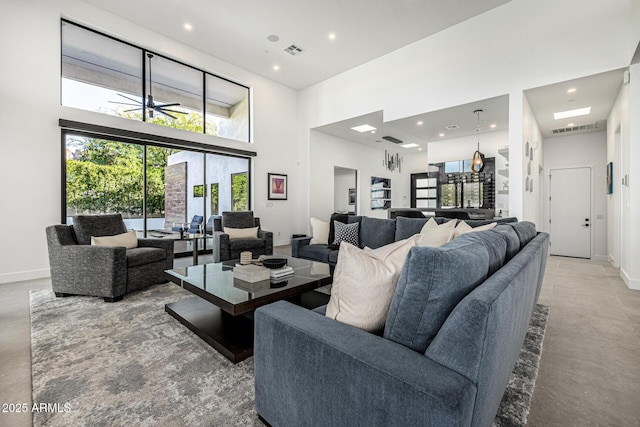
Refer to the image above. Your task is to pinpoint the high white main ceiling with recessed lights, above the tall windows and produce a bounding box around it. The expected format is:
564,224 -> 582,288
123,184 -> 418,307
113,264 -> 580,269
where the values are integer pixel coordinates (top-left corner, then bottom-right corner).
85,0 -> 510,89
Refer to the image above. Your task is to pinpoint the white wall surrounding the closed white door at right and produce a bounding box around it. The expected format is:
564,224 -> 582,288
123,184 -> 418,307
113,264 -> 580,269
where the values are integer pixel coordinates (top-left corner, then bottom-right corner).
542,132 -> 608,260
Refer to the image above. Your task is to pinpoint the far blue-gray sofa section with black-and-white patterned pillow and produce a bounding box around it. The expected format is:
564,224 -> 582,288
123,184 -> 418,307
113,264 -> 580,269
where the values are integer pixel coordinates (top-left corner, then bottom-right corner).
291,214 -> 518,266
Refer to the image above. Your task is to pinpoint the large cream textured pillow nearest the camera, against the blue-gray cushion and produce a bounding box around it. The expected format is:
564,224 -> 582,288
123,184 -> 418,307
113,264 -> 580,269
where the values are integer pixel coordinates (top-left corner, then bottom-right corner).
326,235 -> 420,332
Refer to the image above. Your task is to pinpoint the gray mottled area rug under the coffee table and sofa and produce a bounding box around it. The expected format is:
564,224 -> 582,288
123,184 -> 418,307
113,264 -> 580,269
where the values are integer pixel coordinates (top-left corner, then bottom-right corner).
31,283 -> 548,426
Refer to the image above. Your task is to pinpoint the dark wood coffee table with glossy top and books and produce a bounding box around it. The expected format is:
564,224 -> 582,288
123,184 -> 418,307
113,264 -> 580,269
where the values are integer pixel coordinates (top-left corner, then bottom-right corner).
165,257 -> 331,363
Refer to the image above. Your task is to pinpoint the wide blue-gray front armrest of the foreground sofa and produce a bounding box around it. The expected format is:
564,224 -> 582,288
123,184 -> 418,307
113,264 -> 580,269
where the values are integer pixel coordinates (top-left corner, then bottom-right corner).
254,301 -> 476,426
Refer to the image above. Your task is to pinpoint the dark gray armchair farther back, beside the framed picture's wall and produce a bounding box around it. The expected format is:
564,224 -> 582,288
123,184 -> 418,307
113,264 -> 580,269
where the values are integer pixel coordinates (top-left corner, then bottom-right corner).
213,211 -> 273,262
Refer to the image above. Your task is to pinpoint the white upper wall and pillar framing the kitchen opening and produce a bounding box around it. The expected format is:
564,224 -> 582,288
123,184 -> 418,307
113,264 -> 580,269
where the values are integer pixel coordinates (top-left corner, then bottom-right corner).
298,0 -> 638,237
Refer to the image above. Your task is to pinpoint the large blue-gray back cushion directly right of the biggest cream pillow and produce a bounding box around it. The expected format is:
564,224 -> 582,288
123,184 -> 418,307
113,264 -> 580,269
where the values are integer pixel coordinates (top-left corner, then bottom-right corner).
384,236 -> 490,353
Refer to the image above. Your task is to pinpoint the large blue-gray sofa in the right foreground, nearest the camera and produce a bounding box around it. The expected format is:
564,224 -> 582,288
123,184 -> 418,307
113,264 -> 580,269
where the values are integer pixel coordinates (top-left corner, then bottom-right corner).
254,222 -> 549,426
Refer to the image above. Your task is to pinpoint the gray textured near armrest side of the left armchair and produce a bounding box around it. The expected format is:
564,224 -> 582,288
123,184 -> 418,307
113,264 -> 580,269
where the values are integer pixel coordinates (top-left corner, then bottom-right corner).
49,245 -> 127,298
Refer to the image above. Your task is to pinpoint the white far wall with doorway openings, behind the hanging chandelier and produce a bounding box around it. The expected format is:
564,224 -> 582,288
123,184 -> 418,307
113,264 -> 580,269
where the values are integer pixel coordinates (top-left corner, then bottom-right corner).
303,131 -> 427,227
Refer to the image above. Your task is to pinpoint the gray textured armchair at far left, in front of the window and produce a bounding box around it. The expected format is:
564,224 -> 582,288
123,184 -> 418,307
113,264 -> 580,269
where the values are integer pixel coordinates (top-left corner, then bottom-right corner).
46,214 -> 173,302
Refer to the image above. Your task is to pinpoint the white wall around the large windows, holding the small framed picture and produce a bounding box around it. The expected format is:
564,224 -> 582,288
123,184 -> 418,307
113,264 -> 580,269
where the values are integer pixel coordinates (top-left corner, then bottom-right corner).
0,0 -> 303,283
